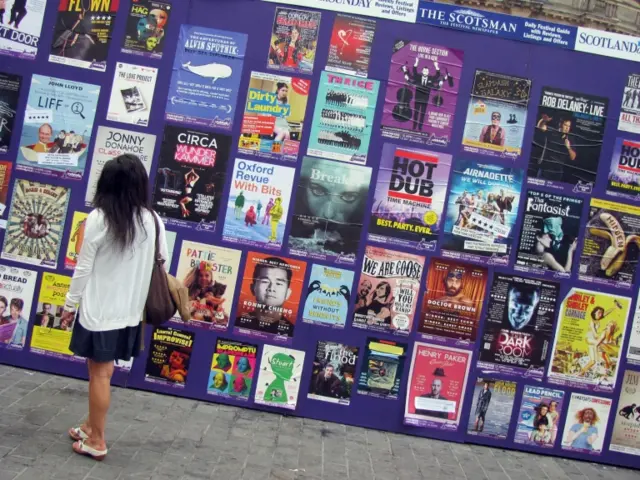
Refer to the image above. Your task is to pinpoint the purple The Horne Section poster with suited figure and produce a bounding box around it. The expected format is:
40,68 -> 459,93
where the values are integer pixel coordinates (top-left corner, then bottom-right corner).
382,40 -> 464,147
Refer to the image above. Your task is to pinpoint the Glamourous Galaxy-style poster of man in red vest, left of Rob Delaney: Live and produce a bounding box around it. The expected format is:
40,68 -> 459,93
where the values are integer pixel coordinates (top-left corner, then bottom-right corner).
462,70 -> 531,160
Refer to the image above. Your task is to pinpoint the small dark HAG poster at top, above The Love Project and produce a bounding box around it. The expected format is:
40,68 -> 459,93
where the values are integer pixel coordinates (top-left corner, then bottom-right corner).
122,0 -> 173,59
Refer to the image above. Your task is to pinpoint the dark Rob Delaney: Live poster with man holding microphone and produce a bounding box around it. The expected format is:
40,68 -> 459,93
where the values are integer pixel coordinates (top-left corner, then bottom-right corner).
527,87 -> 609,194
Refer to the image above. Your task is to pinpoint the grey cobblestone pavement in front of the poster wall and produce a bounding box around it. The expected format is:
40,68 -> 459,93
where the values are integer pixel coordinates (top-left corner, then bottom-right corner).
0,366 -> 640,480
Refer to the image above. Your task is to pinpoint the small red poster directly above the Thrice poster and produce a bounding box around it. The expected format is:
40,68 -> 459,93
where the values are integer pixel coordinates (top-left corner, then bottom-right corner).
325,13 -> 376,78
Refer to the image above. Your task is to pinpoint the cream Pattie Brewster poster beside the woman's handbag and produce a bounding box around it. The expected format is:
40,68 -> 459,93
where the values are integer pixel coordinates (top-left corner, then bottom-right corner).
173,240 -> 242,330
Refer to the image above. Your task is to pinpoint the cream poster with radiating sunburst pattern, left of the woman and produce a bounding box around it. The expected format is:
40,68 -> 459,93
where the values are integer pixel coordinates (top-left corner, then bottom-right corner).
1,179 -> 71,269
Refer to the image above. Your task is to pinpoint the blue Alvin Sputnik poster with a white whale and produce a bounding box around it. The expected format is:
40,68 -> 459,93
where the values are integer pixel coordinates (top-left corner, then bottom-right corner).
165,25 -> 247,130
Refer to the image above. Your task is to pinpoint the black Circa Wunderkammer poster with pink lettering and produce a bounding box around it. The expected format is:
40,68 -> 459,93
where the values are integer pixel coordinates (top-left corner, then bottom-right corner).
153,125 -> 231,232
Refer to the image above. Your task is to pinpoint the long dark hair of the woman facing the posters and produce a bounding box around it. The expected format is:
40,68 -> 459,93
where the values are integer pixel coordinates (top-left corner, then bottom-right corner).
93,153 -> 151,250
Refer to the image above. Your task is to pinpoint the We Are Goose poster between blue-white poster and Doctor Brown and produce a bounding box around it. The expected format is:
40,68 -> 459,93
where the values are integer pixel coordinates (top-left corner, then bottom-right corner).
352,245 -> 424,335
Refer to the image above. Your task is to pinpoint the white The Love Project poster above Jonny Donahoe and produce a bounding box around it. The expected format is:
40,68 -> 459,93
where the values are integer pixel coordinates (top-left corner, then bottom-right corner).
107,62 -> 158,127
